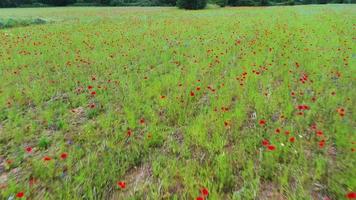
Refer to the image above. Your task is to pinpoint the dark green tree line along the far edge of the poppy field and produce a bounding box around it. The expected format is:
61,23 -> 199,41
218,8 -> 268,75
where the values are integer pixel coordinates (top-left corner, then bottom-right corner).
0,0 -> 356,9
